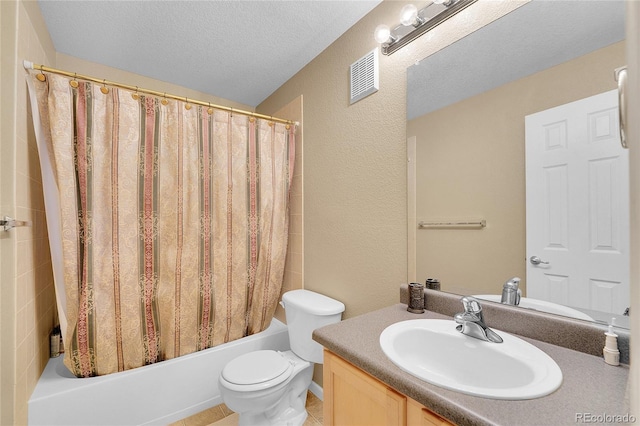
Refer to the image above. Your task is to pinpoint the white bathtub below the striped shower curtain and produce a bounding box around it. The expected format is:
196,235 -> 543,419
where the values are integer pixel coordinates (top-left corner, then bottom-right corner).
29,319 -> 289,426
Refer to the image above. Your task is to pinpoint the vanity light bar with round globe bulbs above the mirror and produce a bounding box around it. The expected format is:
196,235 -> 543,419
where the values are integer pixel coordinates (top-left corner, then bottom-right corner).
374,0 -> 477,55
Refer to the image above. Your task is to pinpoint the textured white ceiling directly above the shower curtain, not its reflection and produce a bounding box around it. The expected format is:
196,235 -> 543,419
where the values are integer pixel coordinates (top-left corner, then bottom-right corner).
39,0 -> 381,106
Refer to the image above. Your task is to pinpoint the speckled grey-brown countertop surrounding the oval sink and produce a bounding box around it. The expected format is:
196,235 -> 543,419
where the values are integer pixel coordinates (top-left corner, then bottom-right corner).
313,303 -> 637,426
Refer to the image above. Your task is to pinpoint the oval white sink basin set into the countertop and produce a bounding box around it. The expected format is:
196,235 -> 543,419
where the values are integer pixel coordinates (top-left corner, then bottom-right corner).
380,319 -> 562,400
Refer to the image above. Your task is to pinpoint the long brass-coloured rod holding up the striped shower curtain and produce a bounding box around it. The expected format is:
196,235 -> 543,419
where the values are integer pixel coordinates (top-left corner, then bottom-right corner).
22,61 -> 300,126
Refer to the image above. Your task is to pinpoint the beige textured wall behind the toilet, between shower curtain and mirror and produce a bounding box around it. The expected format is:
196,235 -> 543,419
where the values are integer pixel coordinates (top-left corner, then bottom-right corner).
258,1 -> 523,318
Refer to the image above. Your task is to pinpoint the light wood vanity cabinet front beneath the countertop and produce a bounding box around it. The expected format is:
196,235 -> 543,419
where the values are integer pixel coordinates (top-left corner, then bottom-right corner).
323,350 -> 452,426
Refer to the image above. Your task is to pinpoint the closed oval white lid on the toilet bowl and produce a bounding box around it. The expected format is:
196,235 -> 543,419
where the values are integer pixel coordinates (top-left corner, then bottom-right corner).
222,350 -> 291,385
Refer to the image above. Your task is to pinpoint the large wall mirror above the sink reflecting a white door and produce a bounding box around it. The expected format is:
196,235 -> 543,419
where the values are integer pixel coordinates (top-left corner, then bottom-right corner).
407,0 -> 629,326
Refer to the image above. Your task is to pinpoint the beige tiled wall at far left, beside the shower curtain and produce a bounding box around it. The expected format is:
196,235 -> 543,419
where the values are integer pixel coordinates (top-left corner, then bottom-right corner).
0,1 -> 56,424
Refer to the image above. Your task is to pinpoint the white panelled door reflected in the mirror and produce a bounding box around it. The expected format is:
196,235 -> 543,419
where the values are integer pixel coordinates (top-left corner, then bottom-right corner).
525,90 -> 629,315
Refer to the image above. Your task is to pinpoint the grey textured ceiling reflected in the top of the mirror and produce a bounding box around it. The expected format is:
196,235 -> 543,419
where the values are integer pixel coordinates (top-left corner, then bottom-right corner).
407,0 -> 625,120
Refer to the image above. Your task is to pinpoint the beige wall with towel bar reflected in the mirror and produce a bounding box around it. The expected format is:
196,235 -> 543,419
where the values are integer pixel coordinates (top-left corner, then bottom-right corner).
407,42 -> 625,294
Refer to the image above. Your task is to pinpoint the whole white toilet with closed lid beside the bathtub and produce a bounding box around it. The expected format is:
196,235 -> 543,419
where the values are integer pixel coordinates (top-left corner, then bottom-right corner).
218,290 -> 344,426
